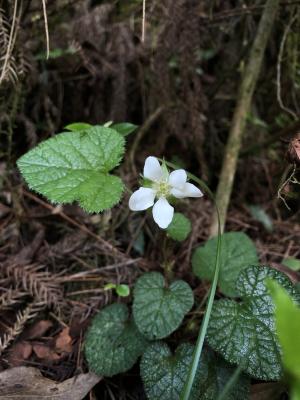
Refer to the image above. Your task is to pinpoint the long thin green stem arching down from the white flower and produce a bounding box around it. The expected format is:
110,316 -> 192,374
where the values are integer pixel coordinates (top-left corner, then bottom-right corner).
164,160 -> 222,400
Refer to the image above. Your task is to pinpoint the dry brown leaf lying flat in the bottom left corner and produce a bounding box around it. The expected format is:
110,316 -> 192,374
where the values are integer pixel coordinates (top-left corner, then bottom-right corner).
0,367 -> 101,400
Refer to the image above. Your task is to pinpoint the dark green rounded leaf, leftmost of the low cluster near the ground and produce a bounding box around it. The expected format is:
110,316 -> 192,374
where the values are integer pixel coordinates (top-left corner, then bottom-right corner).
85,304 -> 147,376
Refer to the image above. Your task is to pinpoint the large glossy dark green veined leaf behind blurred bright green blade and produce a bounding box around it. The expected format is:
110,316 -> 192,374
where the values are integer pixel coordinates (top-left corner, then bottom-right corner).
207,266 -> 299,380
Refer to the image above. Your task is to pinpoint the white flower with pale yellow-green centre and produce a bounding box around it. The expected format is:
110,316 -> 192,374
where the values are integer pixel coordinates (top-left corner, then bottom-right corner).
129,157 -> 203,229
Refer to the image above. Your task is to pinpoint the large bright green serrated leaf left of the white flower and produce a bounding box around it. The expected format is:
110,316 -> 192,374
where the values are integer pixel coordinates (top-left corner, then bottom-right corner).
17,126 -> 124,212
